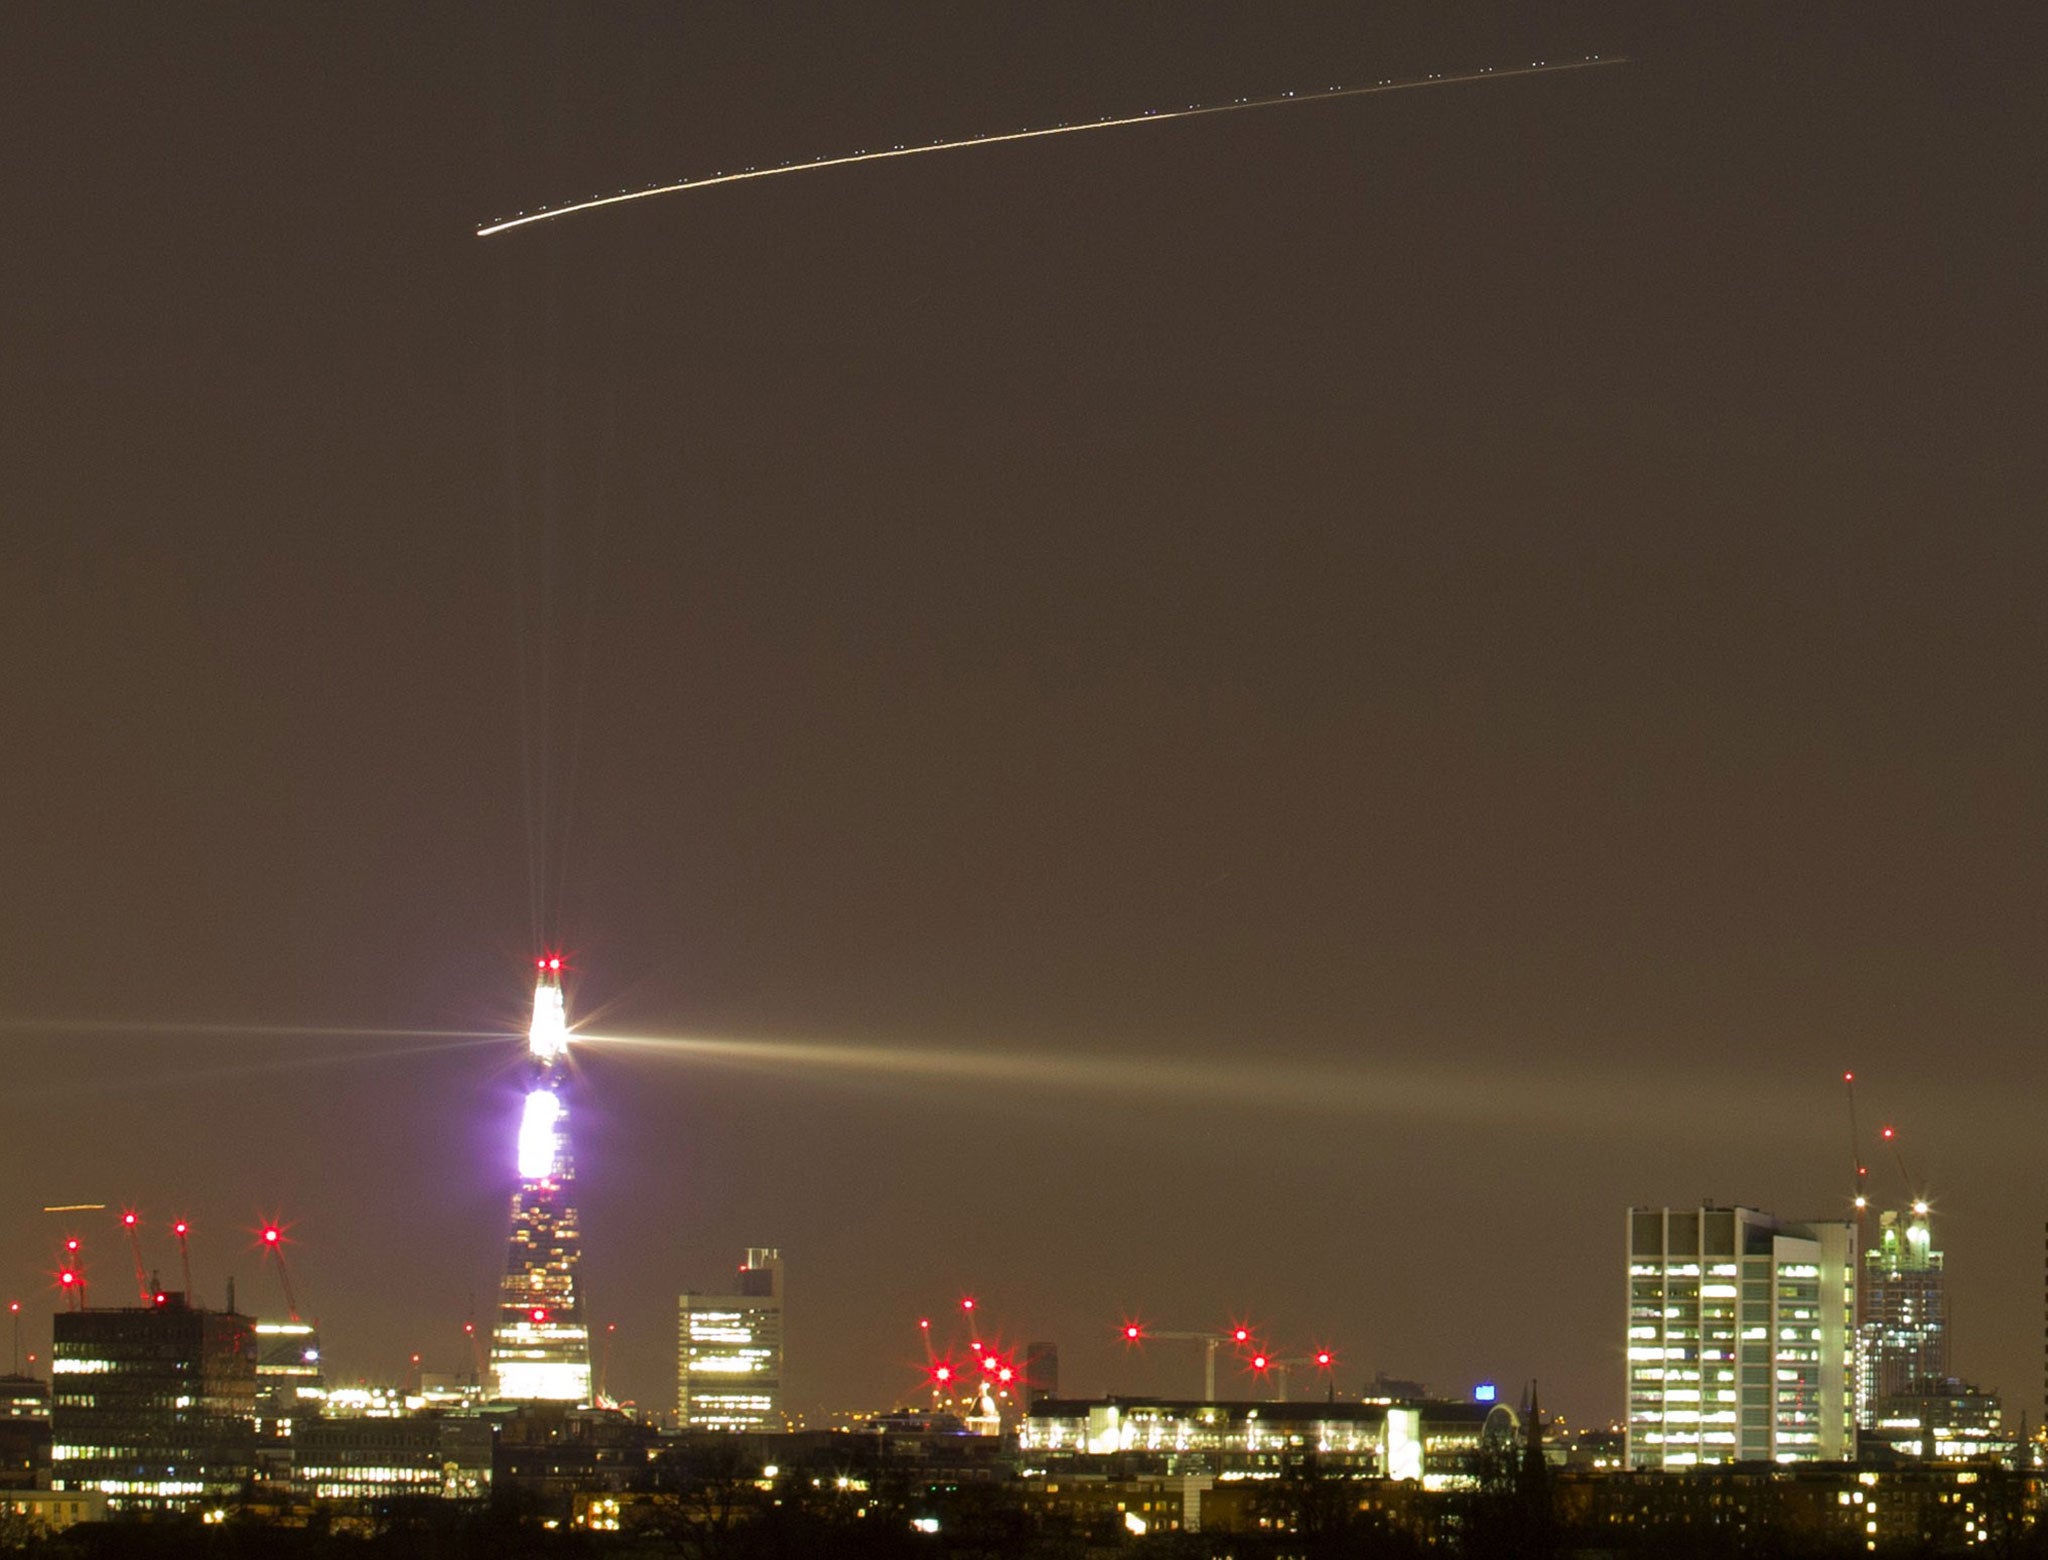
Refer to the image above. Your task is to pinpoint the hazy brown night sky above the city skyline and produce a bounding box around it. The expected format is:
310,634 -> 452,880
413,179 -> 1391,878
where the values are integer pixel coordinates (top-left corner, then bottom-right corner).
0,0 -> 2048,1419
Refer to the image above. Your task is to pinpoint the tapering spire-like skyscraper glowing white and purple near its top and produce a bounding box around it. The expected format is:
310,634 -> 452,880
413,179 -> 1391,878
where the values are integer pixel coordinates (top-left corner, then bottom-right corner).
492,958 -> 590,1402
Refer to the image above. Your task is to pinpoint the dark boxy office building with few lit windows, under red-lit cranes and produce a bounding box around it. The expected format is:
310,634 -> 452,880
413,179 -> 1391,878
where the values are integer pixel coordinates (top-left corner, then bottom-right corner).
49,1294 -> 256,1511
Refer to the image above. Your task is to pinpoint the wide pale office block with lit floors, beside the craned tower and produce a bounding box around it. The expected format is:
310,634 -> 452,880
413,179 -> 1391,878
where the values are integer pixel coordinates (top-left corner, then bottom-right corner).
1628,1208 -> 1855,1468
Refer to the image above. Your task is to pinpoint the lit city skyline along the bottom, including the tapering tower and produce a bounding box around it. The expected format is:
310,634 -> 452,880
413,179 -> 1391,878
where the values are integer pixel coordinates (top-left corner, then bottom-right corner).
0,958 -> 2048,1554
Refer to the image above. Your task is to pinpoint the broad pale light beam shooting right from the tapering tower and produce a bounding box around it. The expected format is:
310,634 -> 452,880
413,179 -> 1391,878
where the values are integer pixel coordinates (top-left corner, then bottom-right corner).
575,1032 -> 1802,1140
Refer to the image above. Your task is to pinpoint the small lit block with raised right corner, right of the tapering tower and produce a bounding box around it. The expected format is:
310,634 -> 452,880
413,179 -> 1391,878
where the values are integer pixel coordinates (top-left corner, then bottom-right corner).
676,1247 -> 782,1431
